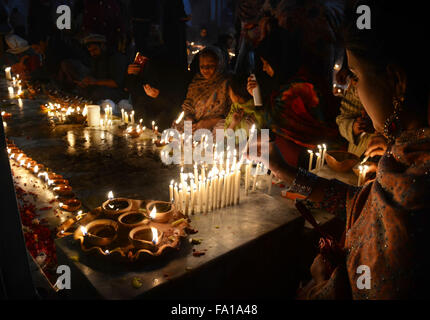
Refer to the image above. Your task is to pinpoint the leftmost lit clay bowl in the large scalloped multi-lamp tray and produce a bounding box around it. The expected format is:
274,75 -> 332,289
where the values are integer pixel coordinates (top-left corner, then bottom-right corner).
81,219 -> 118,247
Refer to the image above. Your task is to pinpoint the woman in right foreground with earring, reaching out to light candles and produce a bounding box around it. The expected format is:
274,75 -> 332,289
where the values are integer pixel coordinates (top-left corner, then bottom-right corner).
249,0 -> 430,299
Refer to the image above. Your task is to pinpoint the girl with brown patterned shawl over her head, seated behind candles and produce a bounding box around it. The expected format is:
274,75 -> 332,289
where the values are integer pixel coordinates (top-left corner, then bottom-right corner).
174,47 -> 231,132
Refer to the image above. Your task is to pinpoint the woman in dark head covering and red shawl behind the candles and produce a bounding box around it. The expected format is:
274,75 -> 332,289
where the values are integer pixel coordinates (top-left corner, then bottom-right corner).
248,32 -> 340,167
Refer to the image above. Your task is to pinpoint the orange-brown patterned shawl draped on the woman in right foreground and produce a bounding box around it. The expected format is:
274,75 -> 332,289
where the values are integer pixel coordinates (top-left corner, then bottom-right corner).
307,128 -> 430,299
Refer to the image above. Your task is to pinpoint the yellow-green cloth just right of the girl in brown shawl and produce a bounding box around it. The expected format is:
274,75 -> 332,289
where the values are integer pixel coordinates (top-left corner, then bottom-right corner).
224,99 -> 264,133
